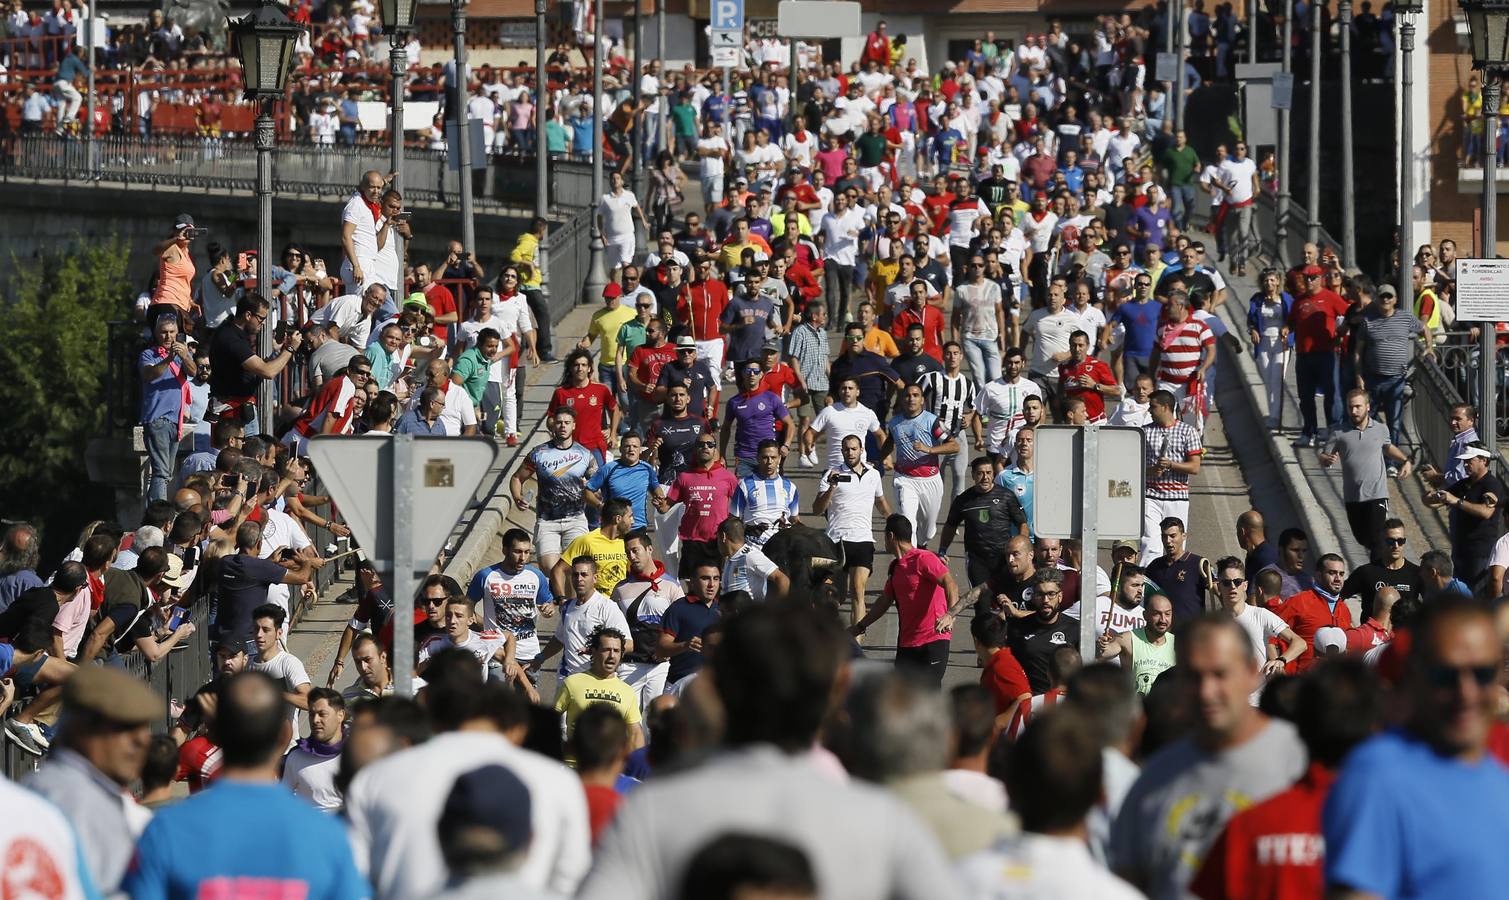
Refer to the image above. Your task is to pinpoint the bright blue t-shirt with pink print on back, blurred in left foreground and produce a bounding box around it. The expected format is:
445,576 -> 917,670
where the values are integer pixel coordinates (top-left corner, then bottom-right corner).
121,781 -> 371,900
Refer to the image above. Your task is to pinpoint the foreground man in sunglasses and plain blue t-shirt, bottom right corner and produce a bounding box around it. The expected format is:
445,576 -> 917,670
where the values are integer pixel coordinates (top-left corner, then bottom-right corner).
1322,596 -> 1509,898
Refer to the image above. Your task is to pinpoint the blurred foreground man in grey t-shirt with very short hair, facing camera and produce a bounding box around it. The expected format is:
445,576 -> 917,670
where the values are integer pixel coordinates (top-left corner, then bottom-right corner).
1111,613 -> 1309,897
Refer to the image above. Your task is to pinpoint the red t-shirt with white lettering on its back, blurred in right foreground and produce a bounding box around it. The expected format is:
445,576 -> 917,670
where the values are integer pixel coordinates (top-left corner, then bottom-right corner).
1189,763 -> 1335,900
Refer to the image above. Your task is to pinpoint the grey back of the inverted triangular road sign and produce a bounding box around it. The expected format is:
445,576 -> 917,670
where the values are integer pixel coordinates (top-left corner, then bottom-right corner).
309,435 -> 498,571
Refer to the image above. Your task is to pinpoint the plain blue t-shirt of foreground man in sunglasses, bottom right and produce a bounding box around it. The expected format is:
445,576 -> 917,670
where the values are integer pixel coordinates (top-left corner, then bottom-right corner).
1322,731 -> 1509,900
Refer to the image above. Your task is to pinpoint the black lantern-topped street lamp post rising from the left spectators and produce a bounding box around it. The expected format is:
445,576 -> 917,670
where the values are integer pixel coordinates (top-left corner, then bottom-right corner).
228,0 -> 303,427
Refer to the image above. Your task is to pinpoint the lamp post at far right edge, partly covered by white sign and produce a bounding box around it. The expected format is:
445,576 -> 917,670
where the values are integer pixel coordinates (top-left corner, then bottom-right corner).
1460,0 -> 1509,458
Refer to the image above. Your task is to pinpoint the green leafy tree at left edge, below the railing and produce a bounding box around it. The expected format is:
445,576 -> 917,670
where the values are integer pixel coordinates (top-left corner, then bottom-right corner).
0,239 -> 131,557
